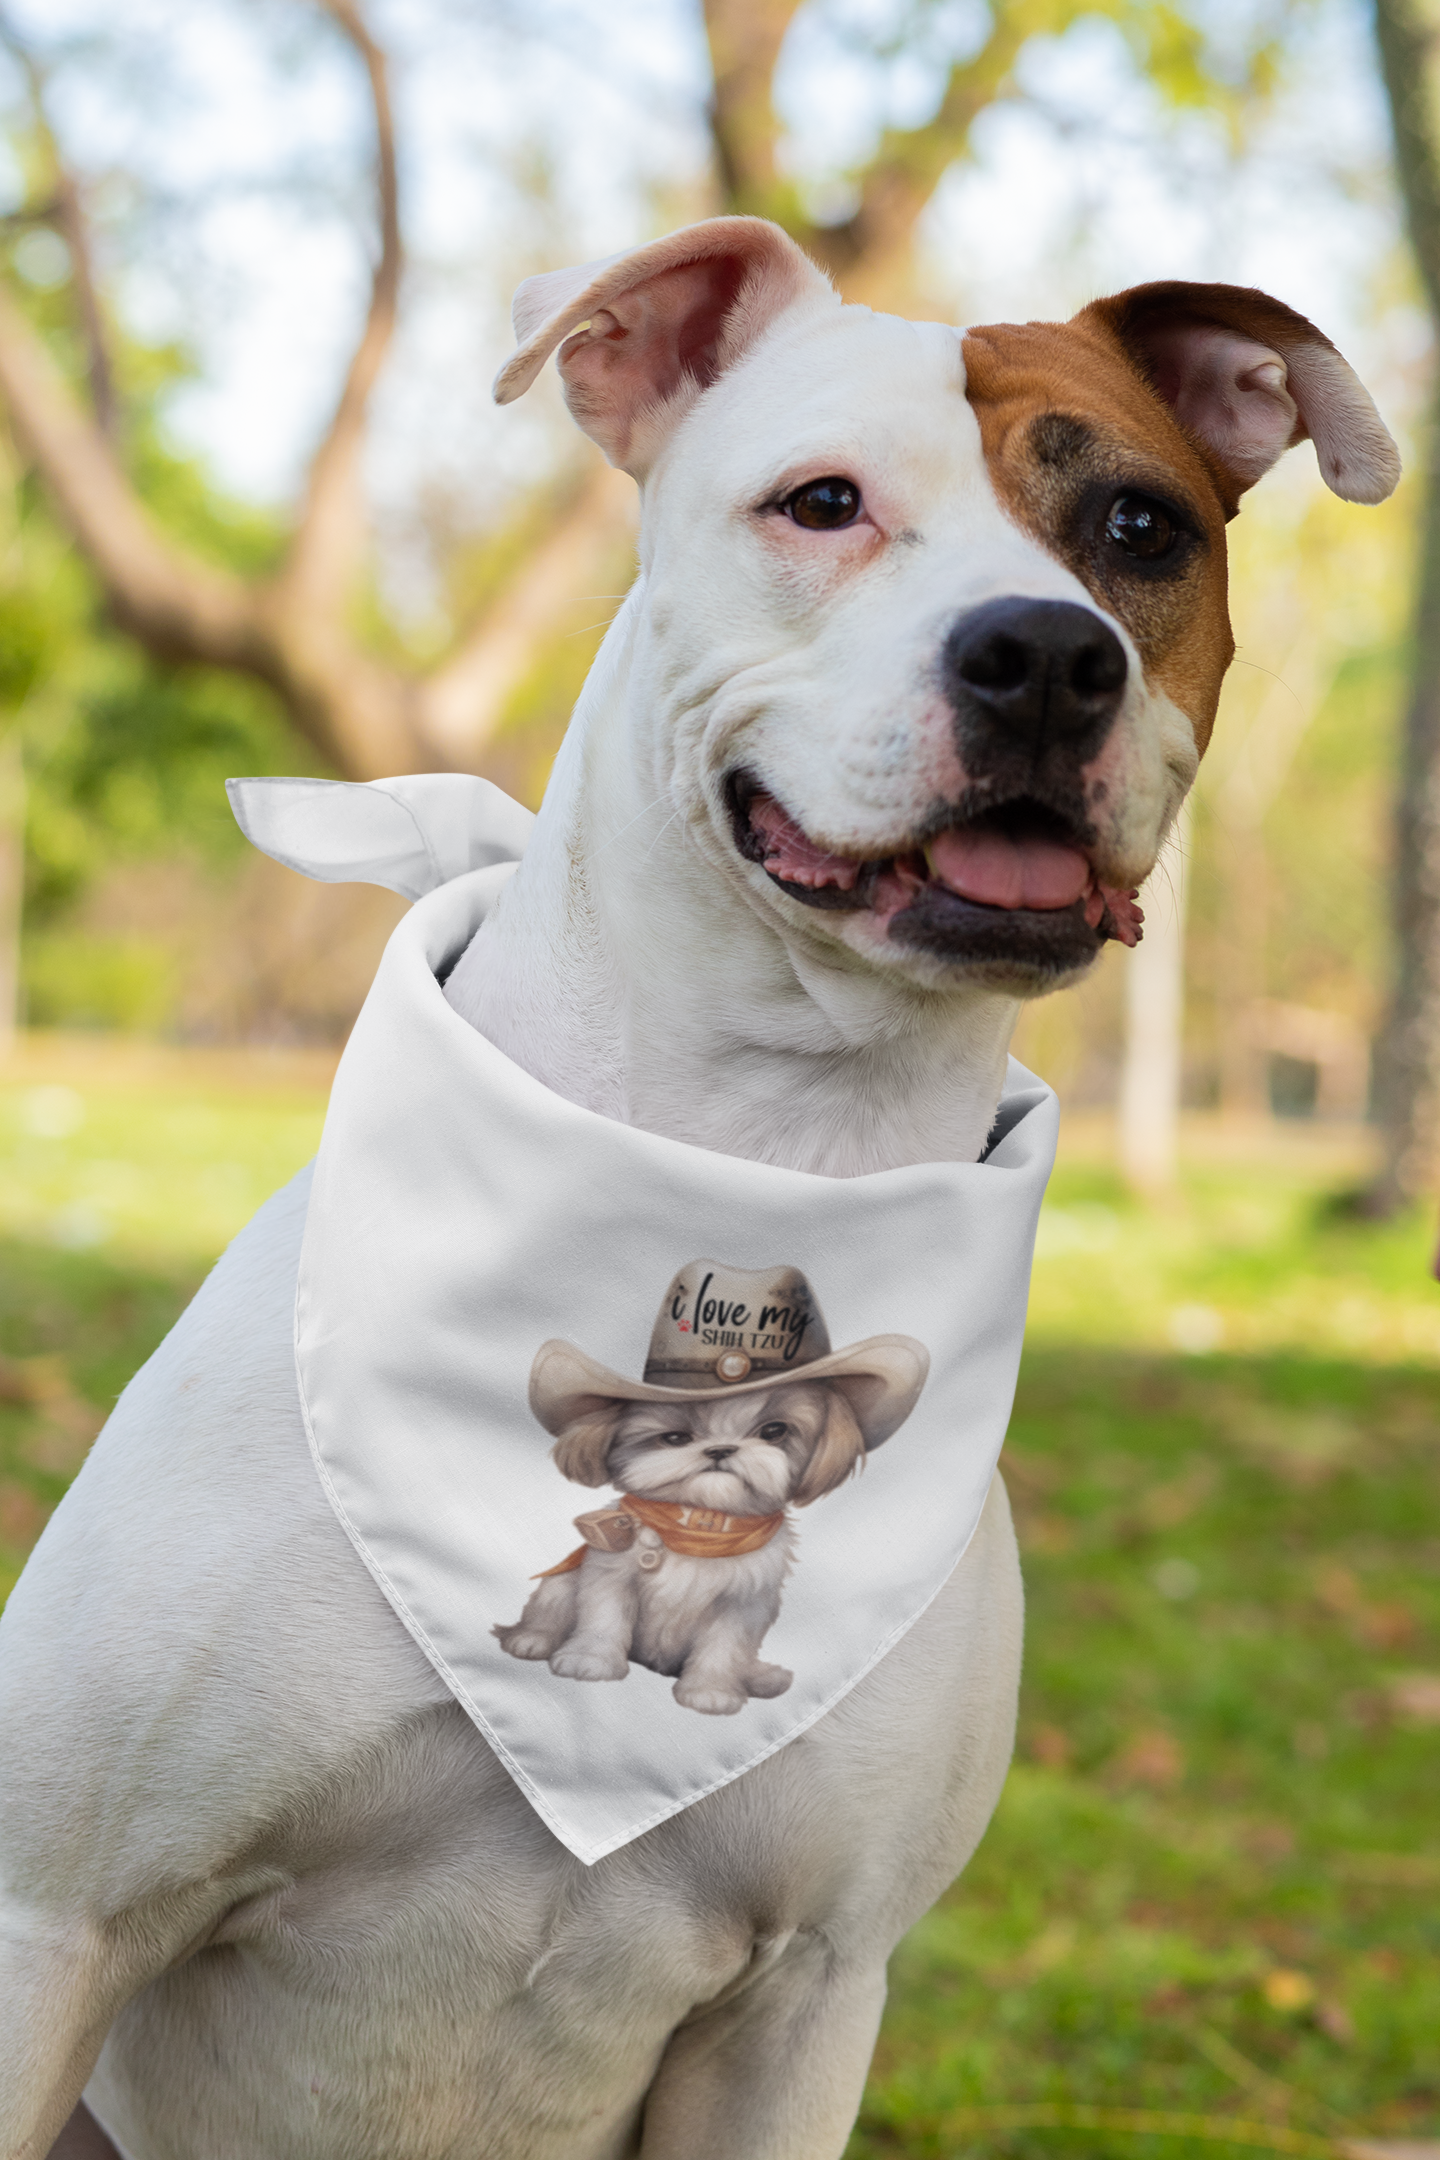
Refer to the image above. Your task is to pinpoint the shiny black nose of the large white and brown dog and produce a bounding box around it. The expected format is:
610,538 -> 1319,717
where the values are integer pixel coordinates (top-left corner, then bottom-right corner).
941,598 -> 1127,754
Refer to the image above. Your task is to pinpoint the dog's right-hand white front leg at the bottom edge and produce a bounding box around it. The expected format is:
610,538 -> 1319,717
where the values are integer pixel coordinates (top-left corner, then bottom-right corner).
641,1933 -> 885,2160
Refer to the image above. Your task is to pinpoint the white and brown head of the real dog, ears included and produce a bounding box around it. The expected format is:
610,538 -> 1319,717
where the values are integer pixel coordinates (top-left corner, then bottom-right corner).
497,218 -> 1399,994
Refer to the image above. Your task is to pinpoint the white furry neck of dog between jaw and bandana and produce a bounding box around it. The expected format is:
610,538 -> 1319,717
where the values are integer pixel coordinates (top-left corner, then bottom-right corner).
445,592 -> 1019,1177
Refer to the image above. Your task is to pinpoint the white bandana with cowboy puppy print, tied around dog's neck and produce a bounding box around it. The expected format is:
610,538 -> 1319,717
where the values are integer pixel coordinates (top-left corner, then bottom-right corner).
231,775 -> 1058,1862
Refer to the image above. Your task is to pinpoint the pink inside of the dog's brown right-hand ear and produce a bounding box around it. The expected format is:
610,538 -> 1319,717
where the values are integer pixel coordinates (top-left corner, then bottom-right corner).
1144,322 -> 1306,484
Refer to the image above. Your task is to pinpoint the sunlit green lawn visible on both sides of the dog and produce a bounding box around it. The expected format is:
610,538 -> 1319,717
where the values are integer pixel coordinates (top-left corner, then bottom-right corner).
0,1045 -> 1440,2160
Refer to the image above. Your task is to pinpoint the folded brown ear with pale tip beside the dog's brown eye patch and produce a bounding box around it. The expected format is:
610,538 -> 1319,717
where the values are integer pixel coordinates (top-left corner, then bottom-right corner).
1075,283 -> 1399,508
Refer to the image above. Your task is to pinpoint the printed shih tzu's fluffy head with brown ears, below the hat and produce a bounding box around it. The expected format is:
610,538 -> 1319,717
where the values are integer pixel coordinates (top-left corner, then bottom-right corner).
553,1380 -> 866,1514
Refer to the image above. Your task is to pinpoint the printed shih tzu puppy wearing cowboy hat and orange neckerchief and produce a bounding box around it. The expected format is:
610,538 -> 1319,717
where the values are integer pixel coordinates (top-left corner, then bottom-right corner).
494,1259 -> 930,1717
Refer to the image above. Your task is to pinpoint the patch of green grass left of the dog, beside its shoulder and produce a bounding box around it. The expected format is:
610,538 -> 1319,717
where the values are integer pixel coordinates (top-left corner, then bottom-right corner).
0,1037 -> 328,1598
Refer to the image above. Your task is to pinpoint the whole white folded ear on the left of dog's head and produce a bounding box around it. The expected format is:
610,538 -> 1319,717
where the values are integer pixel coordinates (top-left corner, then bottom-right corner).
494,218 -> 840,480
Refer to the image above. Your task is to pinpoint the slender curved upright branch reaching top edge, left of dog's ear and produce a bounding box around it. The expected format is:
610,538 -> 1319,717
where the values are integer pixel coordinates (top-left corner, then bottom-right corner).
276,0 -> 404,616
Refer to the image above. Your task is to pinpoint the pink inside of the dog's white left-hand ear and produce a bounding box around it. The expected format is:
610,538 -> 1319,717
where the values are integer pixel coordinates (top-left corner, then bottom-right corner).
559,255 -> 747,464
